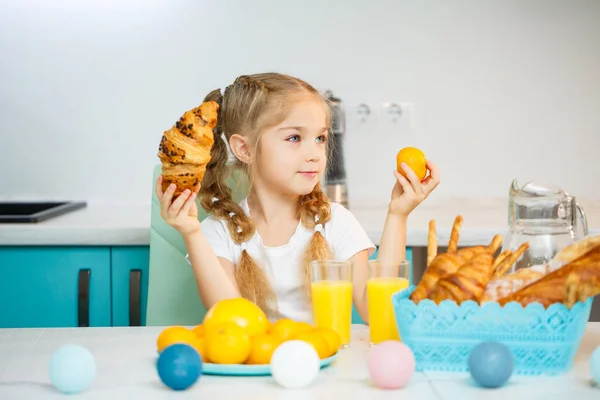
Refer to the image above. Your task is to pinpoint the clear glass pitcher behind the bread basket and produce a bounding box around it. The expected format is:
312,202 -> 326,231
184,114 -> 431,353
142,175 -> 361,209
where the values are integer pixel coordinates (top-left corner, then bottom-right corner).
503,179 -> 588,272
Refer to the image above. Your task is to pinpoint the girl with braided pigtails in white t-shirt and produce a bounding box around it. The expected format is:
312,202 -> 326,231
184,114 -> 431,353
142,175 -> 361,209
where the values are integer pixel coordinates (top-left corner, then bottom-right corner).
156,73 -> 439,323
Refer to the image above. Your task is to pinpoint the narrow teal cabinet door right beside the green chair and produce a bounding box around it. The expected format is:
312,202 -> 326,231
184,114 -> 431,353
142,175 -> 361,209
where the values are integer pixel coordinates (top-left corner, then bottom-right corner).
110,246 -> 150,326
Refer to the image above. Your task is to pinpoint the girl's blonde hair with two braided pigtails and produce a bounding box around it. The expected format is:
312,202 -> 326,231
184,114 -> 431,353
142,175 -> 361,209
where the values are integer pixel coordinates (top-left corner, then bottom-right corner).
199,73 -> 331,315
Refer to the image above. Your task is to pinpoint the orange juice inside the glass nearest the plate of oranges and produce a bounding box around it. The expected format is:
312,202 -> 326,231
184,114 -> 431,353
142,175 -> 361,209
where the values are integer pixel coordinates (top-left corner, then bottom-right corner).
311,280 -> 352,347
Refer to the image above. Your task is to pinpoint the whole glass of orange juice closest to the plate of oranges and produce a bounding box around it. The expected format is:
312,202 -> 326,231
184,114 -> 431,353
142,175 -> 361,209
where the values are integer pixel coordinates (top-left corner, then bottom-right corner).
311,260 -> 353,348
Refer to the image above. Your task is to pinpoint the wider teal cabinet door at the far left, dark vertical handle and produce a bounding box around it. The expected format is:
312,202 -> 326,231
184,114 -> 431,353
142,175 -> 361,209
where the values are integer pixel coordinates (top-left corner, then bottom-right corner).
0,247 -> 111,328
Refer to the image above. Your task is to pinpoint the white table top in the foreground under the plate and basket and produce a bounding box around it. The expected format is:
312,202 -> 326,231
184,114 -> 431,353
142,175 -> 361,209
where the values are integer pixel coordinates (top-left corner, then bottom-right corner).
0,323 -> 600,400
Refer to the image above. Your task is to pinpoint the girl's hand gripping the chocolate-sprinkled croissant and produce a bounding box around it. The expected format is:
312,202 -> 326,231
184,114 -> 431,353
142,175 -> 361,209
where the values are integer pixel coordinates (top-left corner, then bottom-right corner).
156,175 -> 200,236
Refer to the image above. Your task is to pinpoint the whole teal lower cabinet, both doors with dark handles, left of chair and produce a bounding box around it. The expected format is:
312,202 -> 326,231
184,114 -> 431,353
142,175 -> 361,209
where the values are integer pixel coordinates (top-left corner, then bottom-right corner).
0,246 -> 150,328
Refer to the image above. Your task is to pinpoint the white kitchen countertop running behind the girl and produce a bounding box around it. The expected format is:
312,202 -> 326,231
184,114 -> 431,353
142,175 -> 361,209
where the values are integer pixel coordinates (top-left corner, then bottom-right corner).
0,198 -> 600,246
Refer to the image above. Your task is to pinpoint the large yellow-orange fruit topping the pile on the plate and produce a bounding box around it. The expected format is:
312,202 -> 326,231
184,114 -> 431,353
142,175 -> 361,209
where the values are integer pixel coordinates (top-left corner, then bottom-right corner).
202,297 -> 269,336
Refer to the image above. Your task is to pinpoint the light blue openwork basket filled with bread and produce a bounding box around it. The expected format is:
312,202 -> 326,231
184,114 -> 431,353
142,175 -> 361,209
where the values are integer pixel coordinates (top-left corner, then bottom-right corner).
392,286 -> 592,375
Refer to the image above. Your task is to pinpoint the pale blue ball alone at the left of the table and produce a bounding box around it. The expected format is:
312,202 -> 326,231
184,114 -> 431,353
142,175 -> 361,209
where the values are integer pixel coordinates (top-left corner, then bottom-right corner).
50,344 -> 96,394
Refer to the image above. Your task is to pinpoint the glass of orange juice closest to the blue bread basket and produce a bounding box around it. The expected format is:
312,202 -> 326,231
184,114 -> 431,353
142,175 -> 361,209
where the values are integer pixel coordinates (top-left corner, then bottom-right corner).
367,260 -> 410,346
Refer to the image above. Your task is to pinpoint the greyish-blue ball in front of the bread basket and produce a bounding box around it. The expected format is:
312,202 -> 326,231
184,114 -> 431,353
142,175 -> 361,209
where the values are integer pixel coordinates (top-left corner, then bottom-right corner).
469,342 -> 514,388
